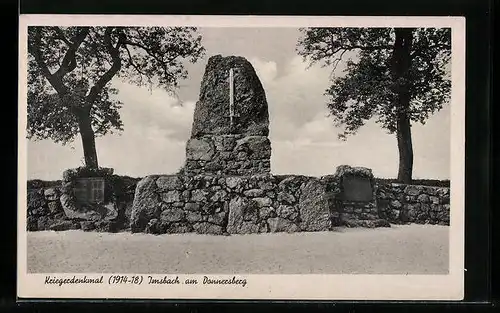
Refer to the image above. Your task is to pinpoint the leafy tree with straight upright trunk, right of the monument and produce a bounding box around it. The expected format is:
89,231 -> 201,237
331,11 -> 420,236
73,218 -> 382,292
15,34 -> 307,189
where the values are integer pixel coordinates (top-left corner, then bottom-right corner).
297,28 -> 451,183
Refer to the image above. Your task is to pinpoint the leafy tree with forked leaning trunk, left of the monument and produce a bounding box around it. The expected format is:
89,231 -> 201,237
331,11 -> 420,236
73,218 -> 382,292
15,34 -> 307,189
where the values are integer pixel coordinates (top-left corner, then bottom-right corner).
27,26 -> 205,169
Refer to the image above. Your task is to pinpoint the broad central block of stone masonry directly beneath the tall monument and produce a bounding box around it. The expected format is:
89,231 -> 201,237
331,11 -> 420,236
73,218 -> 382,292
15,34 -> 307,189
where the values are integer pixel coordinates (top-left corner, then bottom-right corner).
131,175 -> 331,234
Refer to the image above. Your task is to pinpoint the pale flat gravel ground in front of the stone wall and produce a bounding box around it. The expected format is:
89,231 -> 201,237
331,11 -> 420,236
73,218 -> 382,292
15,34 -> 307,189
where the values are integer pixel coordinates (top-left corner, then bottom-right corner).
27,225 -> 449,274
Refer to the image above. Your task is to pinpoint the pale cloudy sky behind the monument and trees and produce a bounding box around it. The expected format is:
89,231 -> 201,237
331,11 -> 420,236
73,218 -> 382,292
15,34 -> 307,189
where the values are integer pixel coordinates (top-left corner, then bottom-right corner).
27,28 -> 450,180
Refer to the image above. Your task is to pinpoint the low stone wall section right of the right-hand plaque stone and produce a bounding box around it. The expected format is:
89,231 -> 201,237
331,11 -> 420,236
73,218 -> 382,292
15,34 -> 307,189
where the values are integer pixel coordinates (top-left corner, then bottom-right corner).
377,183 -> 450,225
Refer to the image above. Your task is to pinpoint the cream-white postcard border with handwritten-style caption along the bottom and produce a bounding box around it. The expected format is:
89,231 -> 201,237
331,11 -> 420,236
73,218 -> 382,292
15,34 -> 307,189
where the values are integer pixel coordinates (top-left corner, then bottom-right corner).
17,15 -> 465,300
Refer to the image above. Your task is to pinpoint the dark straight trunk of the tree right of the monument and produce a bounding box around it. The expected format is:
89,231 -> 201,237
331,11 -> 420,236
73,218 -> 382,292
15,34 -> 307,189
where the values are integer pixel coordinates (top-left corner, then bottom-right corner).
393,28 -> 413,184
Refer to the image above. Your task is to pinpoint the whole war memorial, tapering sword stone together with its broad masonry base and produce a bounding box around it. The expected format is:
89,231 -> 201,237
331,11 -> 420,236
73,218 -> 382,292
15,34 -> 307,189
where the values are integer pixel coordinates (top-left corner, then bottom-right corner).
130,55 -> 398,234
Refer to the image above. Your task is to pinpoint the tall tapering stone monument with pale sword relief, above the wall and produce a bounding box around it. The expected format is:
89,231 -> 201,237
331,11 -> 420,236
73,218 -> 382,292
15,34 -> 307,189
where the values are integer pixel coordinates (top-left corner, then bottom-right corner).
183,55 -> 271,175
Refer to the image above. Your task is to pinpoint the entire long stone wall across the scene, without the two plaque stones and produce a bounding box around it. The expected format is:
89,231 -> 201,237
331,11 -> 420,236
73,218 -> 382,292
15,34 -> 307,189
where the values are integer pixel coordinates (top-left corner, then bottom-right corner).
27,174 -> 450,234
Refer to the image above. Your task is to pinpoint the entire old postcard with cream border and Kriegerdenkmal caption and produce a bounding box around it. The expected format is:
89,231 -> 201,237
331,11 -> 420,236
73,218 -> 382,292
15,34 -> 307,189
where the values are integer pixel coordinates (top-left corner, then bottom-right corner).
18,15 -> 465,300
